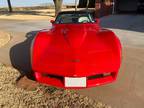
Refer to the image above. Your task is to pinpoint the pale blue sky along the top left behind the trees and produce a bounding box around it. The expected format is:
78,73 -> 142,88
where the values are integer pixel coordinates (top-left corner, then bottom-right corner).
0,0 -> 75,7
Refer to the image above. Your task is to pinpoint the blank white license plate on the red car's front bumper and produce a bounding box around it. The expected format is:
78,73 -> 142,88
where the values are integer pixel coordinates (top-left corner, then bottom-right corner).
65,77 -> 86,87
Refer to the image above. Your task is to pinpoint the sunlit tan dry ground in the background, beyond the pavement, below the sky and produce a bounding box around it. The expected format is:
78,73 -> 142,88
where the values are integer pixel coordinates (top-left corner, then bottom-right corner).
0,8 -> 84,20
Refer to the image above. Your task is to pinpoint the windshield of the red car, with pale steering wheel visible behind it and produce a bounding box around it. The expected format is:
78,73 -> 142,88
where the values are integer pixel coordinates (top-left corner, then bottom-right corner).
55,13 -> 95,24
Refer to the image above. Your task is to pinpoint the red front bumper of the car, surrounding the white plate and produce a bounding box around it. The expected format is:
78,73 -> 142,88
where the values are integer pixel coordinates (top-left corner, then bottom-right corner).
34,72 -> 117,89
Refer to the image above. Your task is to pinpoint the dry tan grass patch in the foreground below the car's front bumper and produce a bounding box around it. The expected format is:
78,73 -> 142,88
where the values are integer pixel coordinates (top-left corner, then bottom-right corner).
0,63 -> 111,108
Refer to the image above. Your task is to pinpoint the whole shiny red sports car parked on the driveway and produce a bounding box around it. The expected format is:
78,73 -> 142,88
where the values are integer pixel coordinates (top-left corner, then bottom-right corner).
31,11 -> 121,88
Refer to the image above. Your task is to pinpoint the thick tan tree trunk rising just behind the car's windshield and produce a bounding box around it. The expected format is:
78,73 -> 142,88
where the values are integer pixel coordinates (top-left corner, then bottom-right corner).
53,0 -> 63,16
